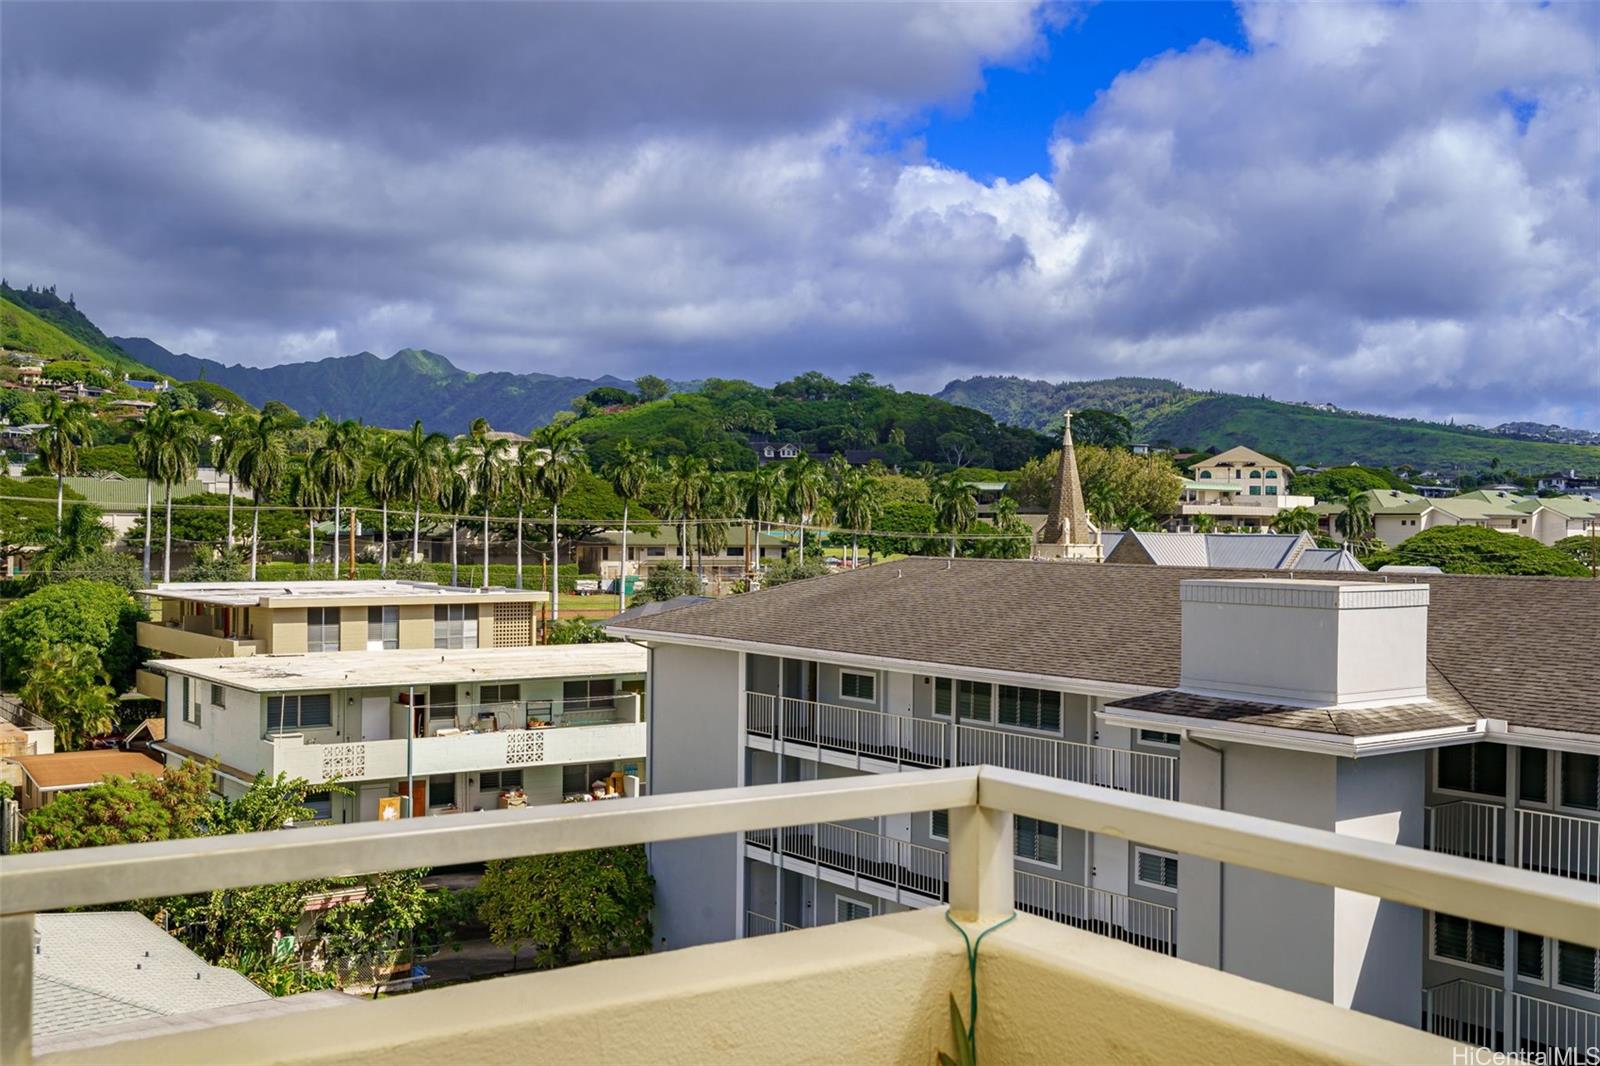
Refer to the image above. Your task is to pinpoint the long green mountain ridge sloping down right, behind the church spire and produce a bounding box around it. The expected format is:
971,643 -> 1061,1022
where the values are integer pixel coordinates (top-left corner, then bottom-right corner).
938,376 -> 1600,474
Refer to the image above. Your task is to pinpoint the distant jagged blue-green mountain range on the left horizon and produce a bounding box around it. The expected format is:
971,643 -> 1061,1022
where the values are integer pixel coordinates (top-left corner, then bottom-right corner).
115,336 -> 630,432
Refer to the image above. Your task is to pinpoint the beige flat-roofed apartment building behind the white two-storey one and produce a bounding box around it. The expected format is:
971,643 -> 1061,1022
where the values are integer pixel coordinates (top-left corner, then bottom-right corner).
136,581 -> 550,699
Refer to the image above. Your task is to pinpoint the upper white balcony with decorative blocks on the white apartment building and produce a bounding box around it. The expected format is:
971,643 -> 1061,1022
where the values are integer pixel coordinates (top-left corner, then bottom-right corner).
262,693 -> 645,784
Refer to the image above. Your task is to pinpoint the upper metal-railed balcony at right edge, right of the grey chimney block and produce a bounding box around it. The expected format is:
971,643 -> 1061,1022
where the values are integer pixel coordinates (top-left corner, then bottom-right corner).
1426,800 -> 1600,882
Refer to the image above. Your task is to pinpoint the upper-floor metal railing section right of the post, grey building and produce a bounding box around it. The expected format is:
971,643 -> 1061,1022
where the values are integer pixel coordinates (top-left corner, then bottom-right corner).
955,725 -> 1178,799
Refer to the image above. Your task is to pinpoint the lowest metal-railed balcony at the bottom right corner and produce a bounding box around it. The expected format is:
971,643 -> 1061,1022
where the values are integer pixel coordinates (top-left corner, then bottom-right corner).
1422,980 -> 1600,1061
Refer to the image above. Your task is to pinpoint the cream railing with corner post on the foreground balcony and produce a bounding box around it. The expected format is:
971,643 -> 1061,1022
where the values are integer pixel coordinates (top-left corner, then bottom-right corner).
0,767 -> 1600,1064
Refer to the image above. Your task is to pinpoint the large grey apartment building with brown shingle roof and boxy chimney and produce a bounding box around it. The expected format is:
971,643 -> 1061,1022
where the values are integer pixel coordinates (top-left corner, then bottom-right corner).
613,559 -> 1600,1047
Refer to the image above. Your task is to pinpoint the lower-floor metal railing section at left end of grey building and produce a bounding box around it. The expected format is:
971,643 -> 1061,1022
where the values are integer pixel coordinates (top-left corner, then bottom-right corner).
744,821 -> 947,903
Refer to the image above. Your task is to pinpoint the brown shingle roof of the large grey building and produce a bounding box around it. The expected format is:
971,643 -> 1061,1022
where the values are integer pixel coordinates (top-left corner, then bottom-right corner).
611,559 -> 1600,735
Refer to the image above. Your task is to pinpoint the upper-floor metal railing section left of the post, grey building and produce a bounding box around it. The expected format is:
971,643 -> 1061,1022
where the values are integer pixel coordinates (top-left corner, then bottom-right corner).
744,691 -> 950,770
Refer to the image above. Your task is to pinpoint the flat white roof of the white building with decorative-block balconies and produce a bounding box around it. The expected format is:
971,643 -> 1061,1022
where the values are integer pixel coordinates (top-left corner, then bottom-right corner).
147,643 -> 648,691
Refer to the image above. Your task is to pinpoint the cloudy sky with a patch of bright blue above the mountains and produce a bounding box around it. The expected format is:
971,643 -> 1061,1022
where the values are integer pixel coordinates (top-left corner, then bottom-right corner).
0,0 -> 1600,427
